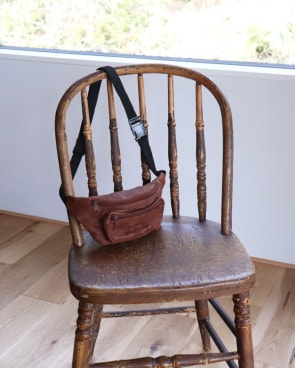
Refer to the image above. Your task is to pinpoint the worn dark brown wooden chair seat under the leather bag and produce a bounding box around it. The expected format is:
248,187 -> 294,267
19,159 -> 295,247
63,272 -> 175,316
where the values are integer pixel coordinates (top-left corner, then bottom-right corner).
69,216 -> 254,304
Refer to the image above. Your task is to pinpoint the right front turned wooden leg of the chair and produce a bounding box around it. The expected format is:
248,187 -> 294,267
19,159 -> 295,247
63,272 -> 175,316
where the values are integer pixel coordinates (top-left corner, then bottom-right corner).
233,292 -> 254,368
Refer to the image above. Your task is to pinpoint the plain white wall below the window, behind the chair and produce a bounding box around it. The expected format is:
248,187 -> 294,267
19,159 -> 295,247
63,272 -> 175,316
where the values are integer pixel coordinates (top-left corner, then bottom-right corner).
0,50 -> 295,264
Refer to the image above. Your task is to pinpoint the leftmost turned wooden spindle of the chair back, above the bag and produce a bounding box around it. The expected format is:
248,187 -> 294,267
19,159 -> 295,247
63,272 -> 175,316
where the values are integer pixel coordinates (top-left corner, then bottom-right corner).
81,88 -> 98,196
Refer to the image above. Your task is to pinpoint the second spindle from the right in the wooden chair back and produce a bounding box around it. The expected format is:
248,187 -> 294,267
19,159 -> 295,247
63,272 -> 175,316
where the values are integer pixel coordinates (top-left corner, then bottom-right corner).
167,74 -> 179,218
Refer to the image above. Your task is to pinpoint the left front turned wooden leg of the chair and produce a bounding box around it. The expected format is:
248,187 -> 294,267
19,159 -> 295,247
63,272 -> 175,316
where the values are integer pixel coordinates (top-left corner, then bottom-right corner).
72,302 -> 94,368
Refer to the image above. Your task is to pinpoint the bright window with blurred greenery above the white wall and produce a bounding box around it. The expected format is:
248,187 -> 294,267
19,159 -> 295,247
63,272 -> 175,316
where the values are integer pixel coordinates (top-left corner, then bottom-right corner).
0,0 -> 295,66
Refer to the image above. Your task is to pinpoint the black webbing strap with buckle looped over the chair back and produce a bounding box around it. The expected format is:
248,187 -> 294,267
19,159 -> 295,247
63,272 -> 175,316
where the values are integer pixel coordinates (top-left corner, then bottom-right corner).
59,66 -> 165,203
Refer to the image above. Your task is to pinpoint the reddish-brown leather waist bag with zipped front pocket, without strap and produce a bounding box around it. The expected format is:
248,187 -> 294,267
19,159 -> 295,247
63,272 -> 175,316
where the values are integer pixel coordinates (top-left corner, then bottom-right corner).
66,173 -> 165,245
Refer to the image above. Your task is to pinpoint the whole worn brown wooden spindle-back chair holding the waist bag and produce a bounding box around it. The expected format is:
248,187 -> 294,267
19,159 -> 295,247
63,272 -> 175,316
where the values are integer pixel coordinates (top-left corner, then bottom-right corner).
56,64 -> 254,368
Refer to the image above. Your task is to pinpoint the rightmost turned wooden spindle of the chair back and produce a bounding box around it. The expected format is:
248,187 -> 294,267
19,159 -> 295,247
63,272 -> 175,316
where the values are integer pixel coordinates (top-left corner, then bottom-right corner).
196,83 -> 207,222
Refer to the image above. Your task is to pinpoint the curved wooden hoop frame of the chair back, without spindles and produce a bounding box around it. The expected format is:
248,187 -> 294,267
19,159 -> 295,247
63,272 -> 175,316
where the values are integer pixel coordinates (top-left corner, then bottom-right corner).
55,64 -> 233,245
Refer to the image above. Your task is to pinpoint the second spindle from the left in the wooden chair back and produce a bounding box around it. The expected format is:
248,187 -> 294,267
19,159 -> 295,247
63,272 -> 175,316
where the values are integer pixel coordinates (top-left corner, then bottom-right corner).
107,80 -> 123,192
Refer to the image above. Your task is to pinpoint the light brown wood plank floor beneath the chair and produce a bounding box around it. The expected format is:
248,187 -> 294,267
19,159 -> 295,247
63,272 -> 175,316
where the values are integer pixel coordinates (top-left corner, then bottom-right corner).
0,212 -> 295,368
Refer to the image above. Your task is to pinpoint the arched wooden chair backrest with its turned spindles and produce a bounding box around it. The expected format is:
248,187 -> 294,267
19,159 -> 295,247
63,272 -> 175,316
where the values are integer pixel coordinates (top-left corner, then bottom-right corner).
56,64 -> 233,245
